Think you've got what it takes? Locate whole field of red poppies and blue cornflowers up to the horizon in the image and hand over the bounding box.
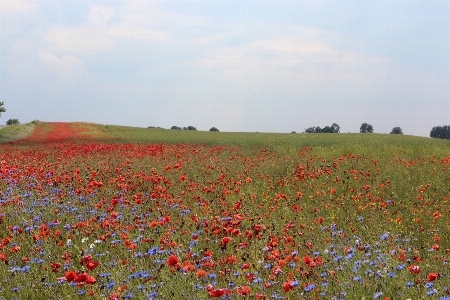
[0,122,450,299]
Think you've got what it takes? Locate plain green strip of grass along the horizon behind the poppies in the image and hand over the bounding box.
[78,123,450,151]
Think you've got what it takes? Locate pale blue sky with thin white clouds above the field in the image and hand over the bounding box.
[0,0,450,136]
